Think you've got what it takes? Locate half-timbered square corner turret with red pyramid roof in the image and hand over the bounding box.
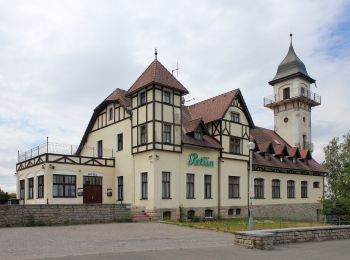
[127,54,188,153]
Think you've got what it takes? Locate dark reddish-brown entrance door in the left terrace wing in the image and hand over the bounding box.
[83,176,102,203]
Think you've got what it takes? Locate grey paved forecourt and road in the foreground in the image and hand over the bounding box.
[0,223,350,260]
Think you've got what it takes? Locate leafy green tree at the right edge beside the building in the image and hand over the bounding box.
[323,132,350,216]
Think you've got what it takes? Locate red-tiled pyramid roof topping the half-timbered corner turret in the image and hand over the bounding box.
[127,59,188,96]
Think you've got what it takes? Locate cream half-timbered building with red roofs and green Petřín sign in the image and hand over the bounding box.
[16,38,326,218]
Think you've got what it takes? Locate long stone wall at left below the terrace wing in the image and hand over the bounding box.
[0,204,130,227]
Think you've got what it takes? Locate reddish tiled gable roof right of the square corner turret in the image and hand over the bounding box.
[188,89,254,126]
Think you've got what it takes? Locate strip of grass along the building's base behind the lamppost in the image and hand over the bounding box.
[166,218,326,233]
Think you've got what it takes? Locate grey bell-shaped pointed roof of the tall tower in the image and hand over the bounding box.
[269,34,315,85]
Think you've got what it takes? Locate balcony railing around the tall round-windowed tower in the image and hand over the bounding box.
[264,88,321,106]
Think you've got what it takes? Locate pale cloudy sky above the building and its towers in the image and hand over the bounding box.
[0,0,350,192]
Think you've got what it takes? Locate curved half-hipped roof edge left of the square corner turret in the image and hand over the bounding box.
[77,88,131,155]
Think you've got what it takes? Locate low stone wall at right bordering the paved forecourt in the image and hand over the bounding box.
[234,225,350,249]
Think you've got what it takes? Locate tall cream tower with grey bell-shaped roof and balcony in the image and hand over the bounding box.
[264,34,321,151]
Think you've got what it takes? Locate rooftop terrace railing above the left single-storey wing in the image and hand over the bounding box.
[18,142,114,162]
